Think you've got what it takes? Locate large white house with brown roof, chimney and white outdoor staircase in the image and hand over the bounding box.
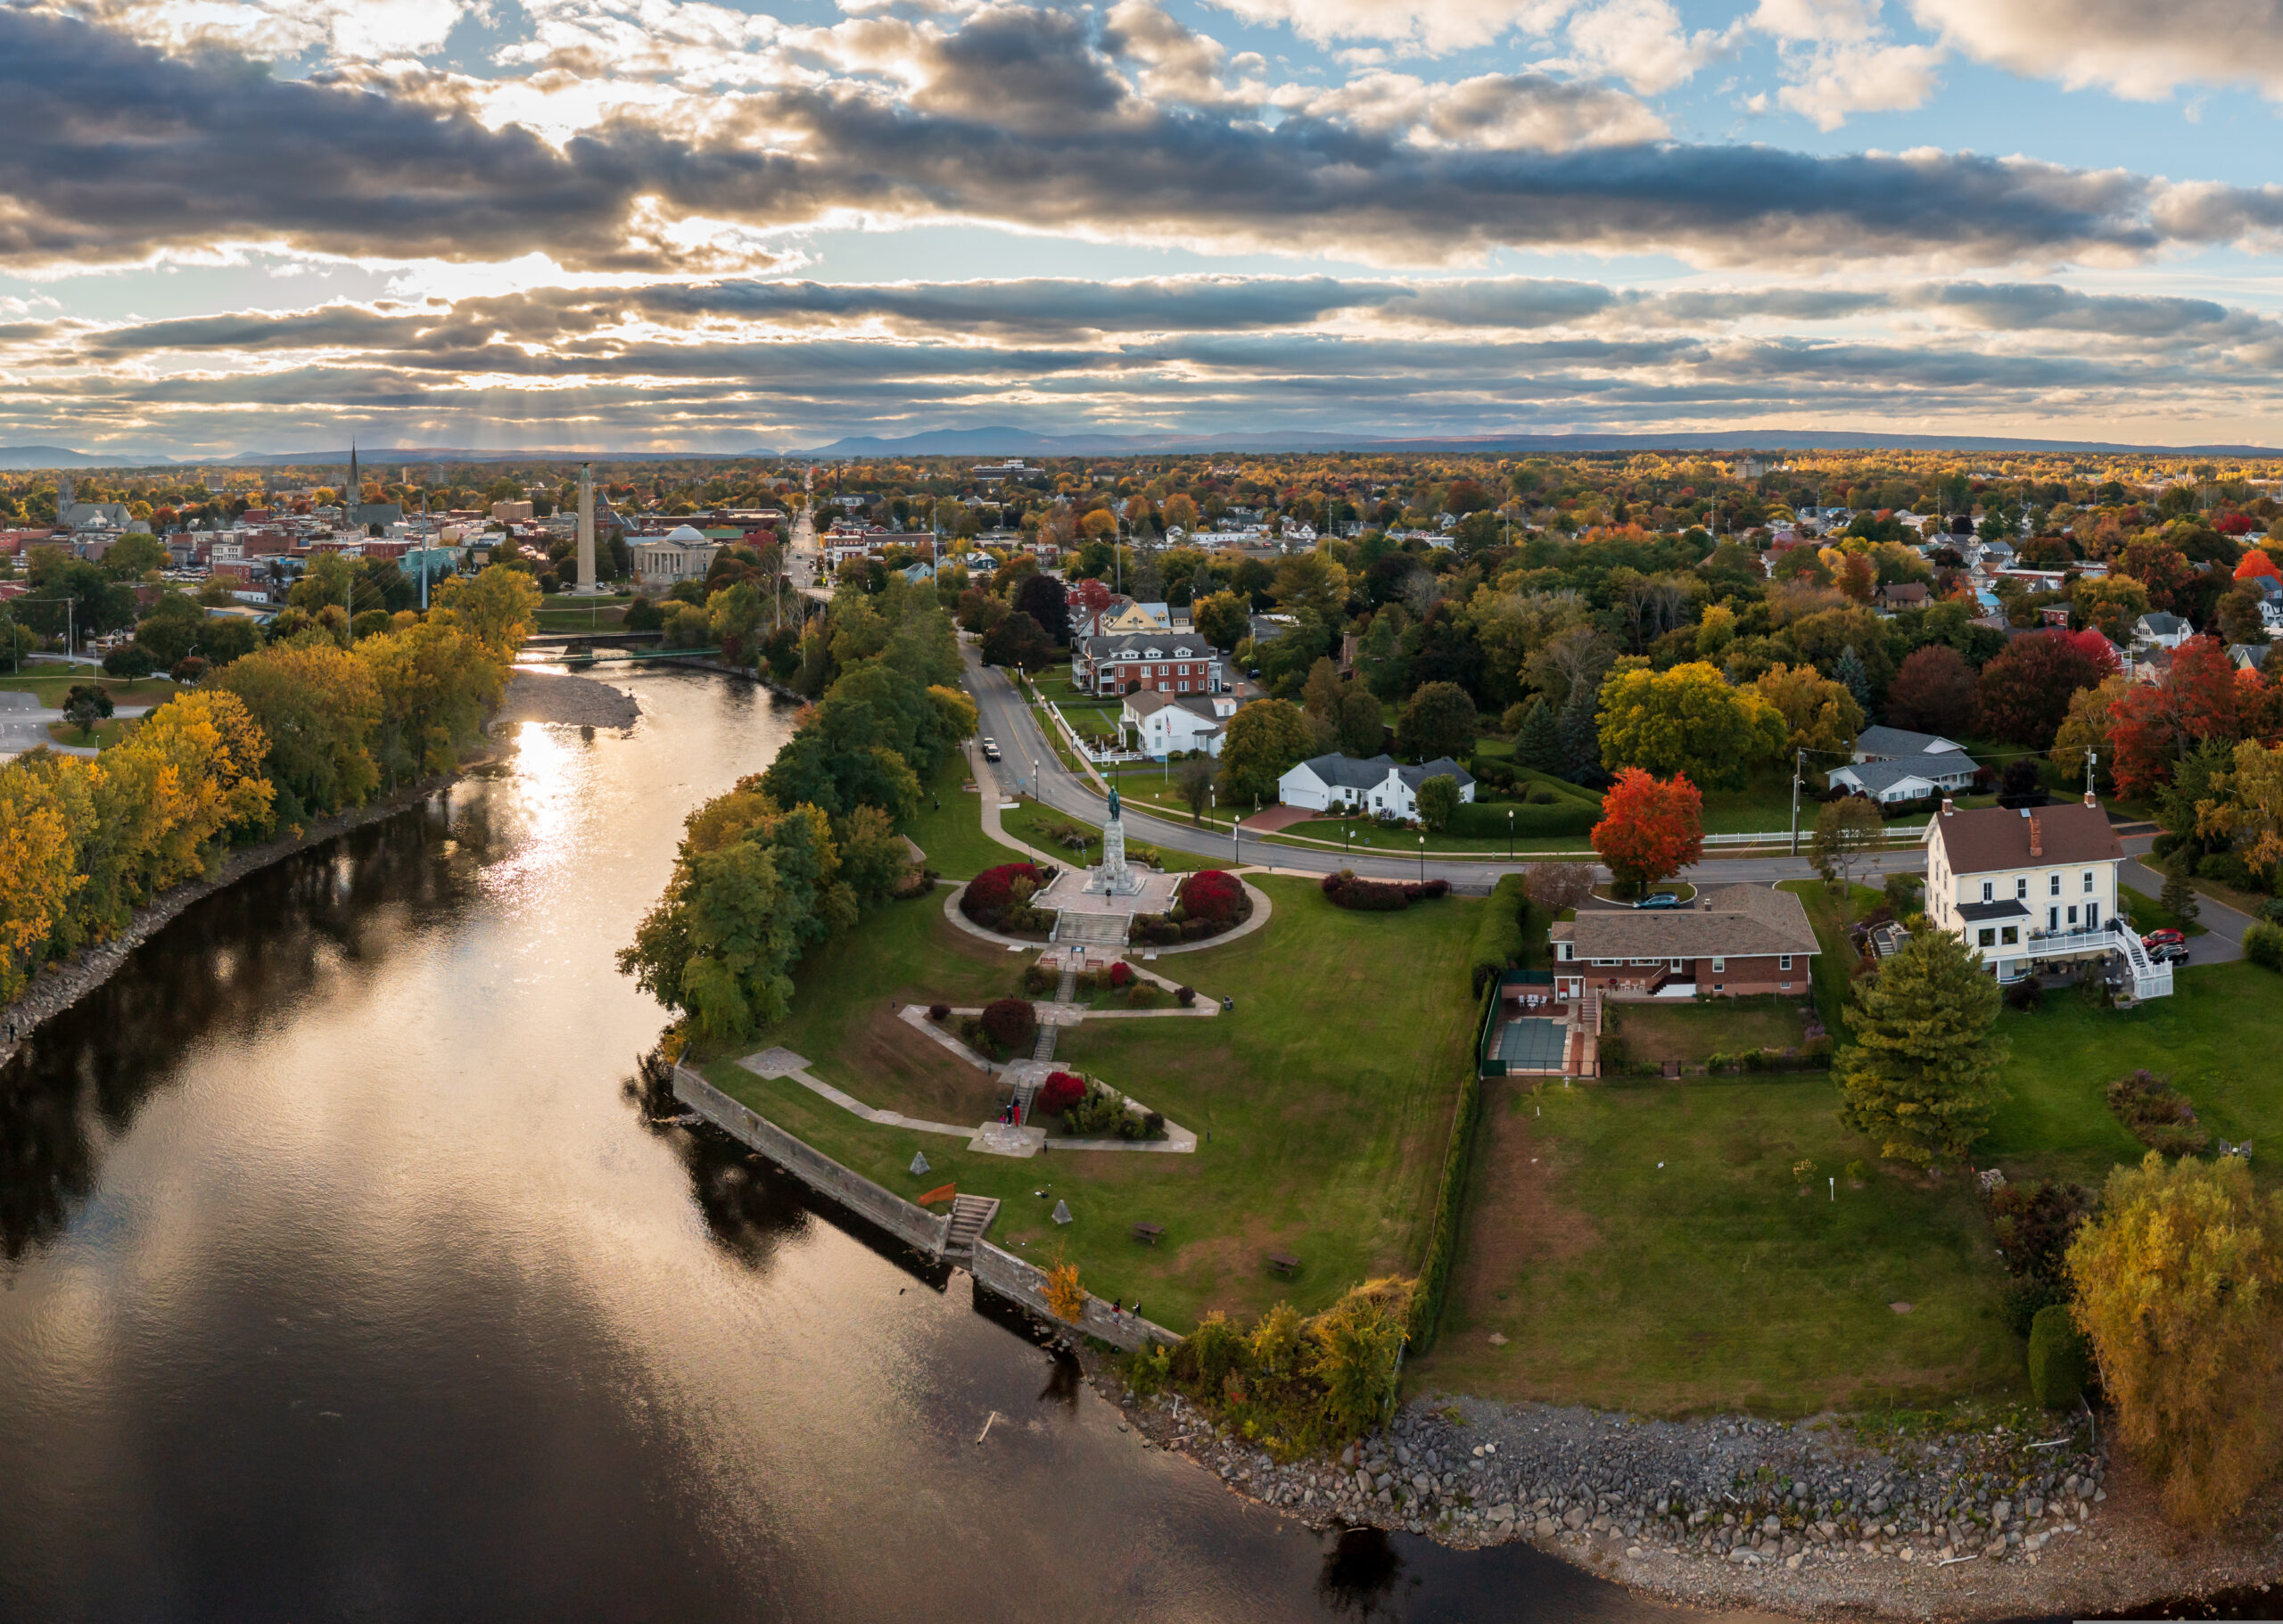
[1927,797,2172,998]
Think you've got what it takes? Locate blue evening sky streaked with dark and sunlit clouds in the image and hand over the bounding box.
[13,0,2283,459]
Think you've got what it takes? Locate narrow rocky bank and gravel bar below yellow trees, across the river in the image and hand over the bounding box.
[0,672,639,1065]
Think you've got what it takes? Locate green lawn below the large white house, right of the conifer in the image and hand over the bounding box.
[1977,961,2283,1188]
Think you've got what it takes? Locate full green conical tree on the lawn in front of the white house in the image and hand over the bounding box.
[1838,929,2007,1167]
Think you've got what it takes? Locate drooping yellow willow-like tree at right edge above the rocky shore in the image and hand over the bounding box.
[2068,1151,2283,1528]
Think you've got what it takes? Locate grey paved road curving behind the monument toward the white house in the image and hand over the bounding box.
[961,644,1927,884]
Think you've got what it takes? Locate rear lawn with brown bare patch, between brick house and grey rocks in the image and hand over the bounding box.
[1411,1074,2025,1416]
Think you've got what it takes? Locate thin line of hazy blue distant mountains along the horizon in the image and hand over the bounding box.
[0,425,2279,473]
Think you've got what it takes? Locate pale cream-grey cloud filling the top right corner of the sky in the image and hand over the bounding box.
[1911,0,2283,101]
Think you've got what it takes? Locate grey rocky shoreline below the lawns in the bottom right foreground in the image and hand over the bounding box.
[1096,1364,2283,1620]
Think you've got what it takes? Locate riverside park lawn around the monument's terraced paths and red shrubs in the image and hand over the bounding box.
[705,877,1481,1330]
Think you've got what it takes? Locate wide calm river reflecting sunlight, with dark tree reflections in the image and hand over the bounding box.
[0,674,1743,1621]
